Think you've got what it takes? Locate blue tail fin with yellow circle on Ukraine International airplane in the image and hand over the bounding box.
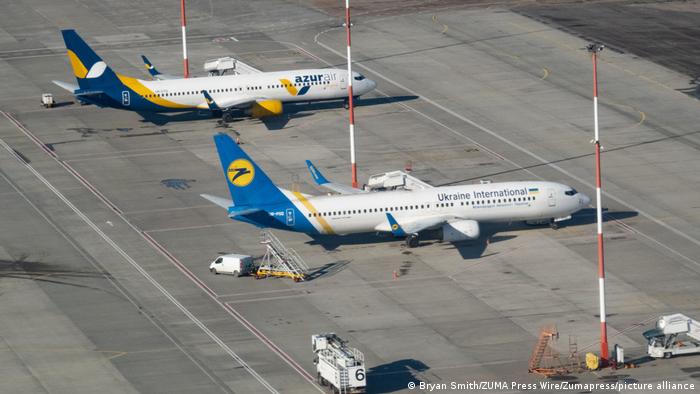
[214,133,289,207]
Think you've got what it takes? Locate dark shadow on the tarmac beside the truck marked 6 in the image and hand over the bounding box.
[367,358,430,393]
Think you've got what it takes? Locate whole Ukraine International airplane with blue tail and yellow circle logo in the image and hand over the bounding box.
[202,134,591,247]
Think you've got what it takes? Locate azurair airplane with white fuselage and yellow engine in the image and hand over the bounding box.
[53,30,377,118]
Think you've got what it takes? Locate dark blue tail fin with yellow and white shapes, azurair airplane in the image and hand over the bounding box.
[61,29,121,90]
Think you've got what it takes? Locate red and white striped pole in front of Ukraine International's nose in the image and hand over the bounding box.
[587,44,608,365]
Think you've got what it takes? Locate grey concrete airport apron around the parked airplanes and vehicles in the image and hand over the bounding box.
[0,1,700,393]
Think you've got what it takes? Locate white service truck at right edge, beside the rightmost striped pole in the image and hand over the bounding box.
[643,313,700,358]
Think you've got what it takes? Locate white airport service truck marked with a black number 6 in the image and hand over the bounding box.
[311,333,367,394]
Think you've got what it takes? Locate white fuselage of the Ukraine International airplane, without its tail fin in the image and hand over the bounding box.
[235,182,590,234]
